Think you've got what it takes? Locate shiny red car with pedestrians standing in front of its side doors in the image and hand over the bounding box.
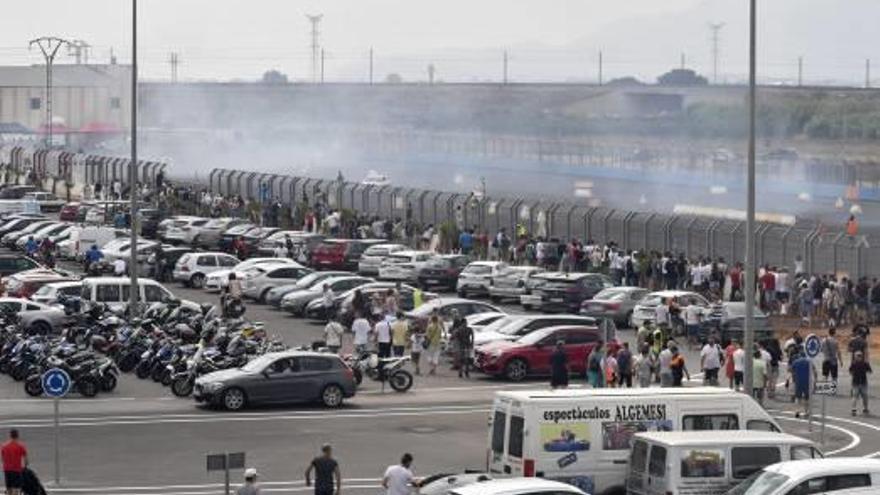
[476,326,619,382]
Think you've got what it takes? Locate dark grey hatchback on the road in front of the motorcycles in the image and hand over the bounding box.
[193,351,357,411]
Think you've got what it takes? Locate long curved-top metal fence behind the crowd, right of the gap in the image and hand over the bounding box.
[209,169,880,277]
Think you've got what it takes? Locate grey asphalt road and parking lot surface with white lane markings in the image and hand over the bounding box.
[0,260,880,495]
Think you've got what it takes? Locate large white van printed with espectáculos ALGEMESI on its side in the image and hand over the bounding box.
[487,387,782,495]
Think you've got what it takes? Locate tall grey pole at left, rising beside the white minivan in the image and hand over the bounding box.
[128,0,140,317]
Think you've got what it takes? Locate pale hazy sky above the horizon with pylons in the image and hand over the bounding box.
[0,0,880,84]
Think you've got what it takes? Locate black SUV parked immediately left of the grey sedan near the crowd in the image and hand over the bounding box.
[520,272,614,313]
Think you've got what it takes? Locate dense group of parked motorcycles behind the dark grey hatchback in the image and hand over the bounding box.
[0,301,285,397]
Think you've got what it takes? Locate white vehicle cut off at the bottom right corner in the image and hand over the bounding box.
[727,457,880,495]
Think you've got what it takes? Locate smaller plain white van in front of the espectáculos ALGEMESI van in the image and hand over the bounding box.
[626,431,823,495]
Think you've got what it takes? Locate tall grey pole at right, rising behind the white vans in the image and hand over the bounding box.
[743,0,758,395]
